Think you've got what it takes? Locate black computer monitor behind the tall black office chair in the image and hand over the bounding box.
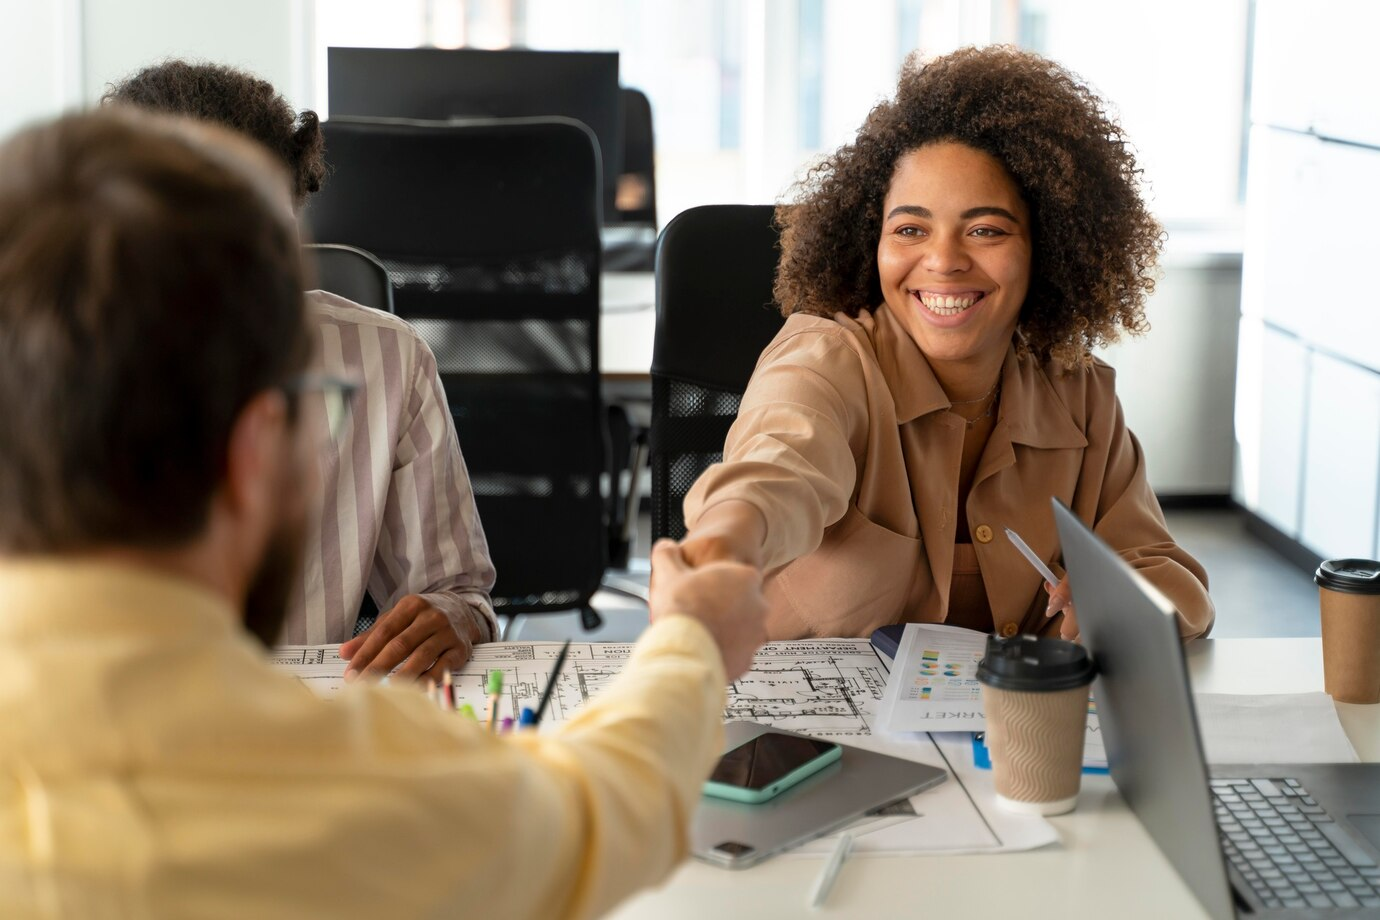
[326,48,622,221]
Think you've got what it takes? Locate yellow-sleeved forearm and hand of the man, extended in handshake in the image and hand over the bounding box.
[463,541,766,917]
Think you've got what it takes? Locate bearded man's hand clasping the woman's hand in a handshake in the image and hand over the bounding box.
[647,539,767,680]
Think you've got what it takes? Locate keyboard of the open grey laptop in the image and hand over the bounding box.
[1210,779,1380,908]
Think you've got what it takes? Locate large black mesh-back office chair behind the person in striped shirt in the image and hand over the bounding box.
[306,119,617,628]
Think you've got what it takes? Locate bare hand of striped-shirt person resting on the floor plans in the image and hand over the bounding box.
[341,594,484,680]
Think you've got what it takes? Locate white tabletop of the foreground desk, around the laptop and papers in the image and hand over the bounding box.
[611,639,1380,920]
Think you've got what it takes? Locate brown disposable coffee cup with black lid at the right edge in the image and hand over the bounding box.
[1314,559,1380,703]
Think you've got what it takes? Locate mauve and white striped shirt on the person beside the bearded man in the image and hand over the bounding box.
[280,291,498,644]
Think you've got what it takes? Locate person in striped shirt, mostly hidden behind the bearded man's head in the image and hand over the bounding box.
[102,61,498,679]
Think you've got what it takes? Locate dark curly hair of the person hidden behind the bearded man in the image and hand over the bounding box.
[101,61,326,208]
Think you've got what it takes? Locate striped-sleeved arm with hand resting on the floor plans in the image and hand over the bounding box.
[341,339,498,679]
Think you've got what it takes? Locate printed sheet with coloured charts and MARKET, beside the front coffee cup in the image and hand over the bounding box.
[878,623,987,731]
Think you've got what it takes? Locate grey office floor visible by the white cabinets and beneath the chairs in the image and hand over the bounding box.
[508,509,1318,641]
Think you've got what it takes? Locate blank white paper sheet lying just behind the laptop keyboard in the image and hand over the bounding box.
[1194,692,1361,764]
